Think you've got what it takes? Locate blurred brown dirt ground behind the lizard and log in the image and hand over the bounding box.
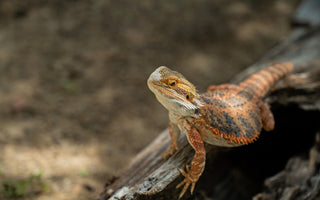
[0,0,298,200]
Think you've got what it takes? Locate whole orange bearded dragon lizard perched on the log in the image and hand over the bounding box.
[148,63,293,199]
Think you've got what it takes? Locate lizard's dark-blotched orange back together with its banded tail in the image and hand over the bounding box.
[194,63,293,146]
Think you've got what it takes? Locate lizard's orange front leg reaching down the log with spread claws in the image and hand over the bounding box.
[177,125,206,199]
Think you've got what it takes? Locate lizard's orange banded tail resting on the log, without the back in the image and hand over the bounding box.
[239,62,293,97]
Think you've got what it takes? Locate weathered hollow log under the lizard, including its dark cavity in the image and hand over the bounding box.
[101,0,320,200]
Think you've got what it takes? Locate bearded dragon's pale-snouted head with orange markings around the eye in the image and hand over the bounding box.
[148,66,202,117]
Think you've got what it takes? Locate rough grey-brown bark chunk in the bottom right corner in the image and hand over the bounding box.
[253,132,320,200]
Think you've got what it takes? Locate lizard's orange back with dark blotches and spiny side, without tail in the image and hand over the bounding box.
[197,89,262,146]
